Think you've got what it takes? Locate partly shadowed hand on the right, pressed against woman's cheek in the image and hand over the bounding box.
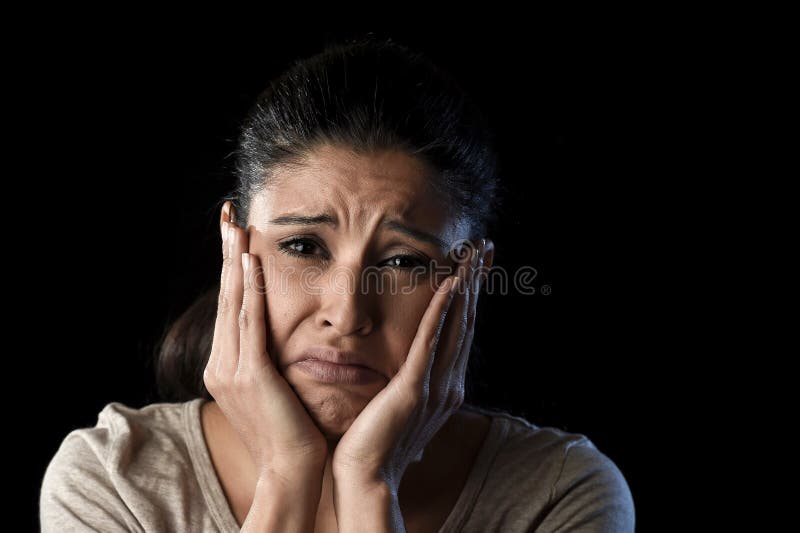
[332,241,483,495]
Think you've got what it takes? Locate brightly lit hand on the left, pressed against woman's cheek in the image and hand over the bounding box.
[203,206,327,482]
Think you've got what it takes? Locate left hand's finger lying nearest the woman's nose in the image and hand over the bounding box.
[239,253,274,373]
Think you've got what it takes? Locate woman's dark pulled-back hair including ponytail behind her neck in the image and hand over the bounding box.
[155,36,501,401]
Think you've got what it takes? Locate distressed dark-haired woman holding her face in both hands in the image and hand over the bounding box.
[40,35,634,531]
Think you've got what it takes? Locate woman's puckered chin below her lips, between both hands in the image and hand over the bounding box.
[292,383,380,440]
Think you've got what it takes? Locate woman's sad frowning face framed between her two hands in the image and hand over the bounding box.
[241,145,468,438]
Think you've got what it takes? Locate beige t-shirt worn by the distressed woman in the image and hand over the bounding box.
[39,398,634,533]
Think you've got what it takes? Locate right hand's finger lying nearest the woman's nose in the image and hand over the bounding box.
[398,276,459,388]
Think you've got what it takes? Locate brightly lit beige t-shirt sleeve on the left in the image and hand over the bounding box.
[39,428,144,533]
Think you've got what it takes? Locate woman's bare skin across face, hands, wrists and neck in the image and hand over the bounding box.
[203,146,493,531]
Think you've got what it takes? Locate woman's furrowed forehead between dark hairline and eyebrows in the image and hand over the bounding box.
[251,145,455,231]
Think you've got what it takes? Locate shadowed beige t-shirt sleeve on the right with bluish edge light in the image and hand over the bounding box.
[536,439,635,533]
